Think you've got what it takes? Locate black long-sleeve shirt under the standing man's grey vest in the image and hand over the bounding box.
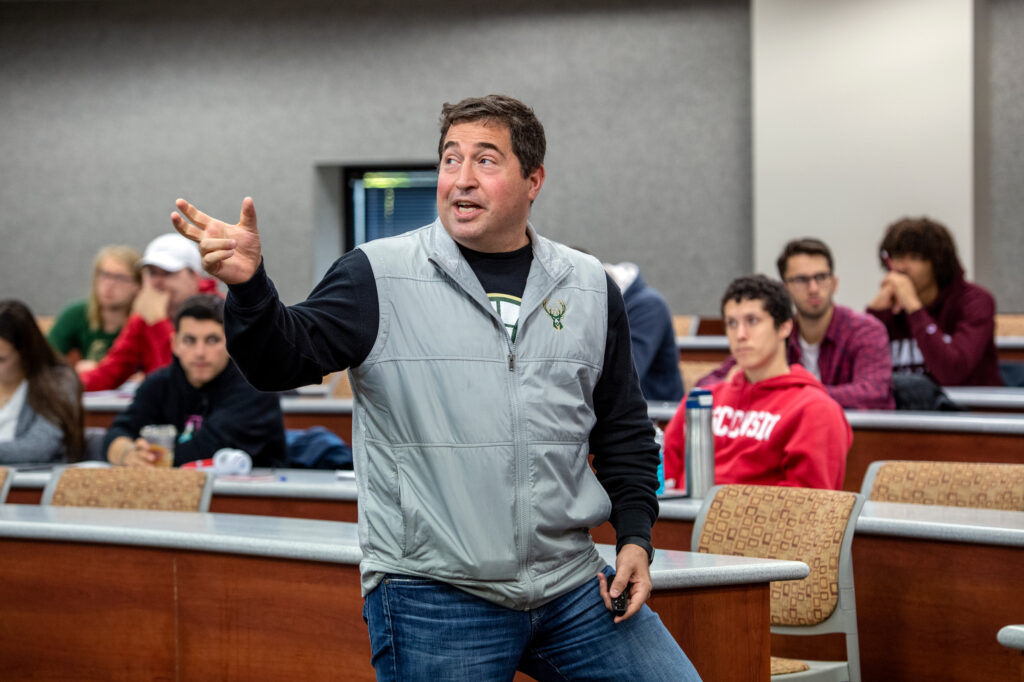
[224,246,658,551]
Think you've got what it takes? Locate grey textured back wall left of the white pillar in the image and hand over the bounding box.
[0,0,751,313]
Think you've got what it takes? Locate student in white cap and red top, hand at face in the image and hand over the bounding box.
[79,232,216,391]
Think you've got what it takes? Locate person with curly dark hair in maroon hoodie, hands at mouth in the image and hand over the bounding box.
[867,218,1002,386]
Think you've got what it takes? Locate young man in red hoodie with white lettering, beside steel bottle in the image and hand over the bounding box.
[665,274,853,489]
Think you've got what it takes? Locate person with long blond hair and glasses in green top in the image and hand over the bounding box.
[47,246,141,372]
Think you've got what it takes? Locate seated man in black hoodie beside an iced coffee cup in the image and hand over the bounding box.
[103,294,285,466]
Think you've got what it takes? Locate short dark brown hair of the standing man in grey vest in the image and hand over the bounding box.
[437,95,547,177]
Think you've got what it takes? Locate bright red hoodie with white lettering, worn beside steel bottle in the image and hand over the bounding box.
[665,365,853,491]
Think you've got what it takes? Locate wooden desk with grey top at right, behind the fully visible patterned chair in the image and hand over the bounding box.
[614,493,1024,682]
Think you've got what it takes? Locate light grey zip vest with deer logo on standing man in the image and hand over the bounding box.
[350,221,611,609]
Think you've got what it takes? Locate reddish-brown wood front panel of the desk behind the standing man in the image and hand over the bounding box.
[0,539,768,682]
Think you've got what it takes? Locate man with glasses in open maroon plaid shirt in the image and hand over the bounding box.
[697,238,895,410]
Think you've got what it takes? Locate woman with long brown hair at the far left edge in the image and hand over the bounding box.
[0,300,84,464]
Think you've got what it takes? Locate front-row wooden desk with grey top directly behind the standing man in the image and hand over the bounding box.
[0,505,808,681]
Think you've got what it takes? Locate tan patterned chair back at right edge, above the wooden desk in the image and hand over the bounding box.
[861,461,1024,511]
